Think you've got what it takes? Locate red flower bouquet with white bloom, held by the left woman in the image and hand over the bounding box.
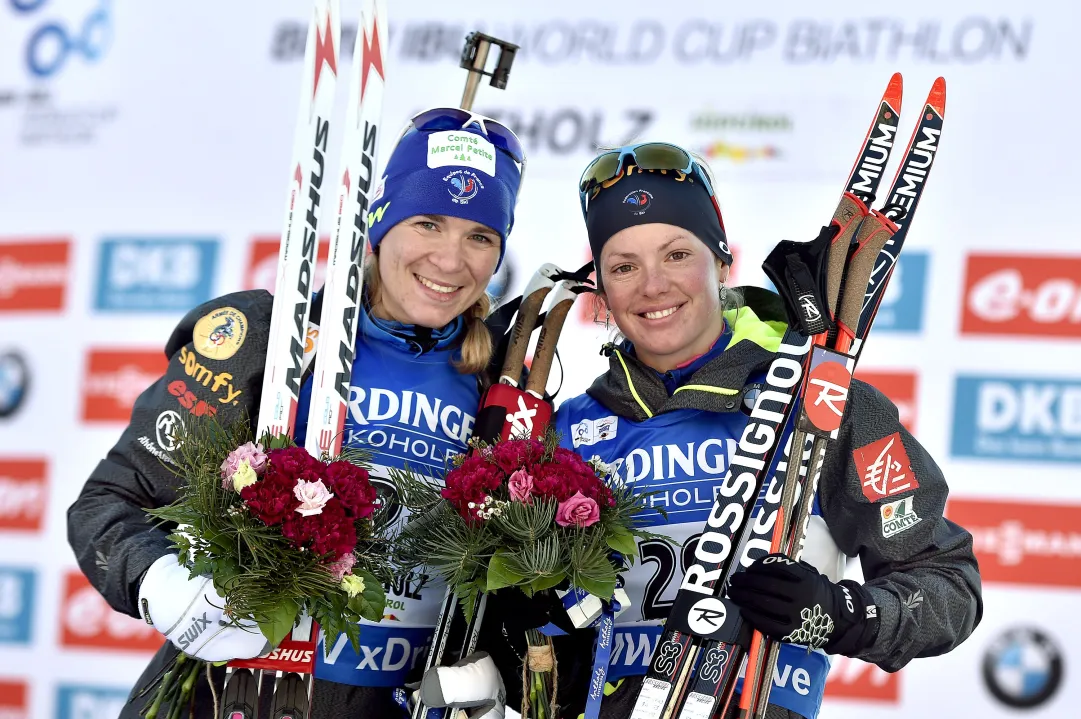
[146,417,390,717]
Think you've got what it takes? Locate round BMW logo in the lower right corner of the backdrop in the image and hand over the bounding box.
[984,627,1063,709]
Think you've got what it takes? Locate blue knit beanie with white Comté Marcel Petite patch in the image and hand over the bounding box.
[368,123,522,269]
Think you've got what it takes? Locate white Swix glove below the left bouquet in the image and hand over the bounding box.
[138,555,271,662]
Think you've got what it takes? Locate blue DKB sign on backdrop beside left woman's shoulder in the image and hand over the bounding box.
[94,238,217,312]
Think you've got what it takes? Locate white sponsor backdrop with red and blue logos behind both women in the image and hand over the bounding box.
[0,0,1081,719]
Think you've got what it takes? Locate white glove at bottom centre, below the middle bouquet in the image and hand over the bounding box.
[421,652,508,719]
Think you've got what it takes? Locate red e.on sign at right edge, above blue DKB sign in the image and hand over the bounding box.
[961,254,1081,337]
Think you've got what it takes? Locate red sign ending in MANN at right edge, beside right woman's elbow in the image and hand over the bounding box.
[946,500,1081,587]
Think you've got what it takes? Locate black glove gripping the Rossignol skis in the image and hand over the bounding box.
[729,554,878,656]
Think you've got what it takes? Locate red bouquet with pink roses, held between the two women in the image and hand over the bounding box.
[391,431,663,719]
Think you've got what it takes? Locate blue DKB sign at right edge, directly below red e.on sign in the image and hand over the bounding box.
[951,376,1081,462]
